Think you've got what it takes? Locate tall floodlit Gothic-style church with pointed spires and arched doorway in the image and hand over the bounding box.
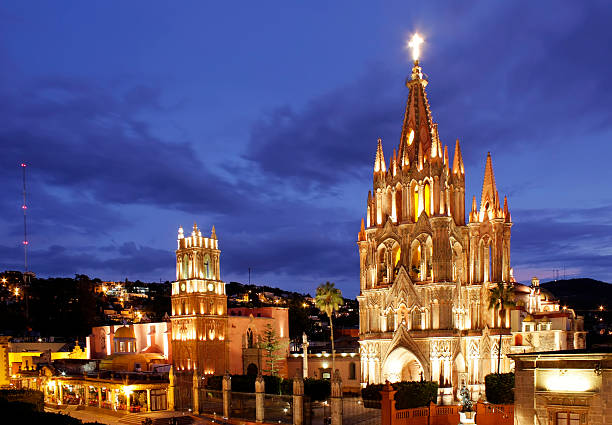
[357,57,512,391]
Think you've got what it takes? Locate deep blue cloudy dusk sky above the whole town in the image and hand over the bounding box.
[0,1,612,295]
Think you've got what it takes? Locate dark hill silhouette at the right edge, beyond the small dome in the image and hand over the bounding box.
[540,278,612,311]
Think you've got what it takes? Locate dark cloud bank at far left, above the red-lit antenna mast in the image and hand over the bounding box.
[0,78,250,212]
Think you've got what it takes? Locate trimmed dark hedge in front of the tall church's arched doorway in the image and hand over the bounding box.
[361,381,438,409]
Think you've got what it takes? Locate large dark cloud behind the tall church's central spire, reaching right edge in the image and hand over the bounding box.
[245,2,612,190]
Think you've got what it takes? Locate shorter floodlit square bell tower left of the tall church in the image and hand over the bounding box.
[170,223,229,375]
